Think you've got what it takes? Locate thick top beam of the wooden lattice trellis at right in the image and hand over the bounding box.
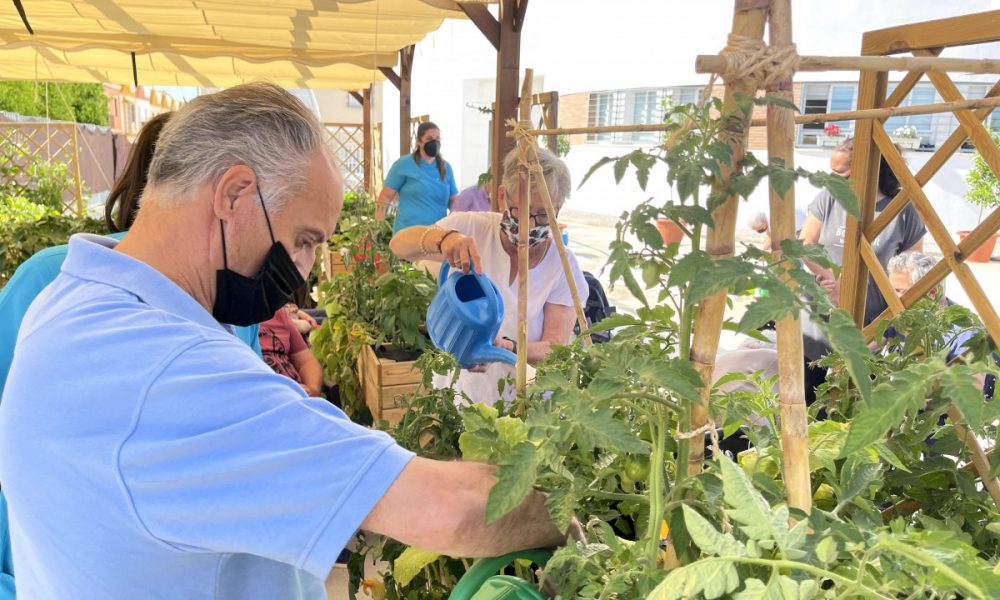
[861,10,1000,54]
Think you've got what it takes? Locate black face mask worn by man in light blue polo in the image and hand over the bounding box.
[212,185,305,327]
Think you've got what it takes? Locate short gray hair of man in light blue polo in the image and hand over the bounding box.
[149,83,324,211]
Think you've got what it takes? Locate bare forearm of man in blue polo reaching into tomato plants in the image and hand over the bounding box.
[361,457,566,558]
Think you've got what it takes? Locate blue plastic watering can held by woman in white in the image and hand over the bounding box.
[427,262,517,369]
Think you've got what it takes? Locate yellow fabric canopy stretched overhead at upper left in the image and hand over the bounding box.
[0,0,476,90]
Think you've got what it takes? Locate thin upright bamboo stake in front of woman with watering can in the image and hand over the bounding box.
[520,69,533,397]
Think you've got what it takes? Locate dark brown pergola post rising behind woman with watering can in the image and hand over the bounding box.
[490,0,527,210]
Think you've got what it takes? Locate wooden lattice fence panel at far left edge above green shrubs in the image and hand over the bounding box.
[0,121,84,215]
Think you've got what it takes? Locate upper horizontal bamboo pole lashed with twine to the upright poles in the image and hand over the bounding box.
[694,54,1000,75]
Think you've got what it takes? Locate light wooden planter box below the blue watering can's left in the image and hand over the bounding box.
[358,346,420,425]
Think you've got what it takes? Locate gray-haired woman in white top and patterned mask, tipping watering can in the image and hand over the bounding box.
[389,148,588,404]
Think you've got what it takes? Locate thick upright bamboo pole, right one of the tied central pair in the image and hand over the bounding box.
[767,0,812,513]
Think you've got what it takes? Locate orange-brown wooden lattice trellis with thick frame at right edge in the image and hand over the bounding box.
[841,18,1000,350]
